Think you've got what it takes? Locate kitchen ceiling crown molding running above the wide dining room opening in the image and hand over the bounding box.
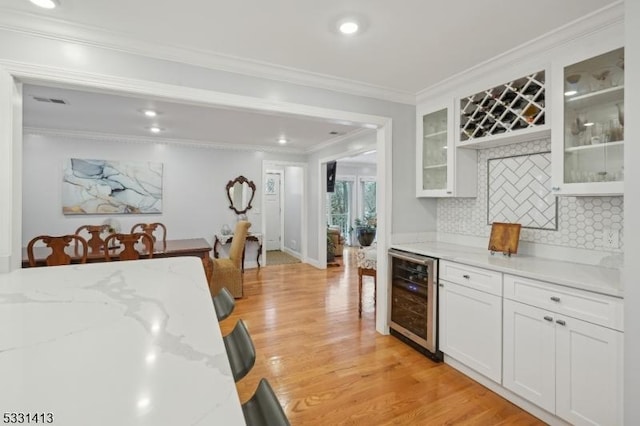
[0,9,415,105]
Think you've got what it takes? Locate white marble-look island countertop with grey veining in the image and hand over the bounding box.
[0,257,245,426]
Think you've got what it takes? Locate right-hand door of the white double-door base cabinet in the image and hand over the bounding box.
[555,317,623,425]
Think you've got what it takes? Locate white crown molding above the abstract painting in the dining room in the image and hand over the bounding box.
[23,126,306,155]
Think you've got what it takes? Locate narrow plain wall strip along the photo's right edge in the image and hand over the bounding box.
[623,0,640,425]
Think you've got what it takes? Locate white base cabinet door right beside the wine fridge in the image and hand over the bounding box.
[439,281,502,383]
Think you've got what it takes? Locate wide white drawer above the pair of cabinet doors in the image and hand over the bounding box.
[504,274,624,331]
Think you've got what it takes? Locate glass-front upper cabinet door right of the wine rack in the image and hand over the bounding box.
[552,48,624,195]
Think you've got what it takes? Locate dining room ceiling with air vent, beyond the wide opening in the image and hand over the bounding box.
[23,84,373,153]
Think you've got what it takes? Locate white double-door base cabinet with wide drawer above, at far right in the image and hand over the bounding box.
[503,275,623,425]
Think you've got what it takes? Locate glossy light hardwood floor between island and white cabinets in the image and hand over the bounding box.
[221,250,544,425]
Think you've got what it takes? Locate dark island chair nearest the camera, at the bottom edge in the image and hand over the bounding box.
[242,378,291,426]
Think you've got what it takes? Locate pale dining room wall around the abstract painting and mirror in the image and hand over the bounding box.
[22,134,300,250]
